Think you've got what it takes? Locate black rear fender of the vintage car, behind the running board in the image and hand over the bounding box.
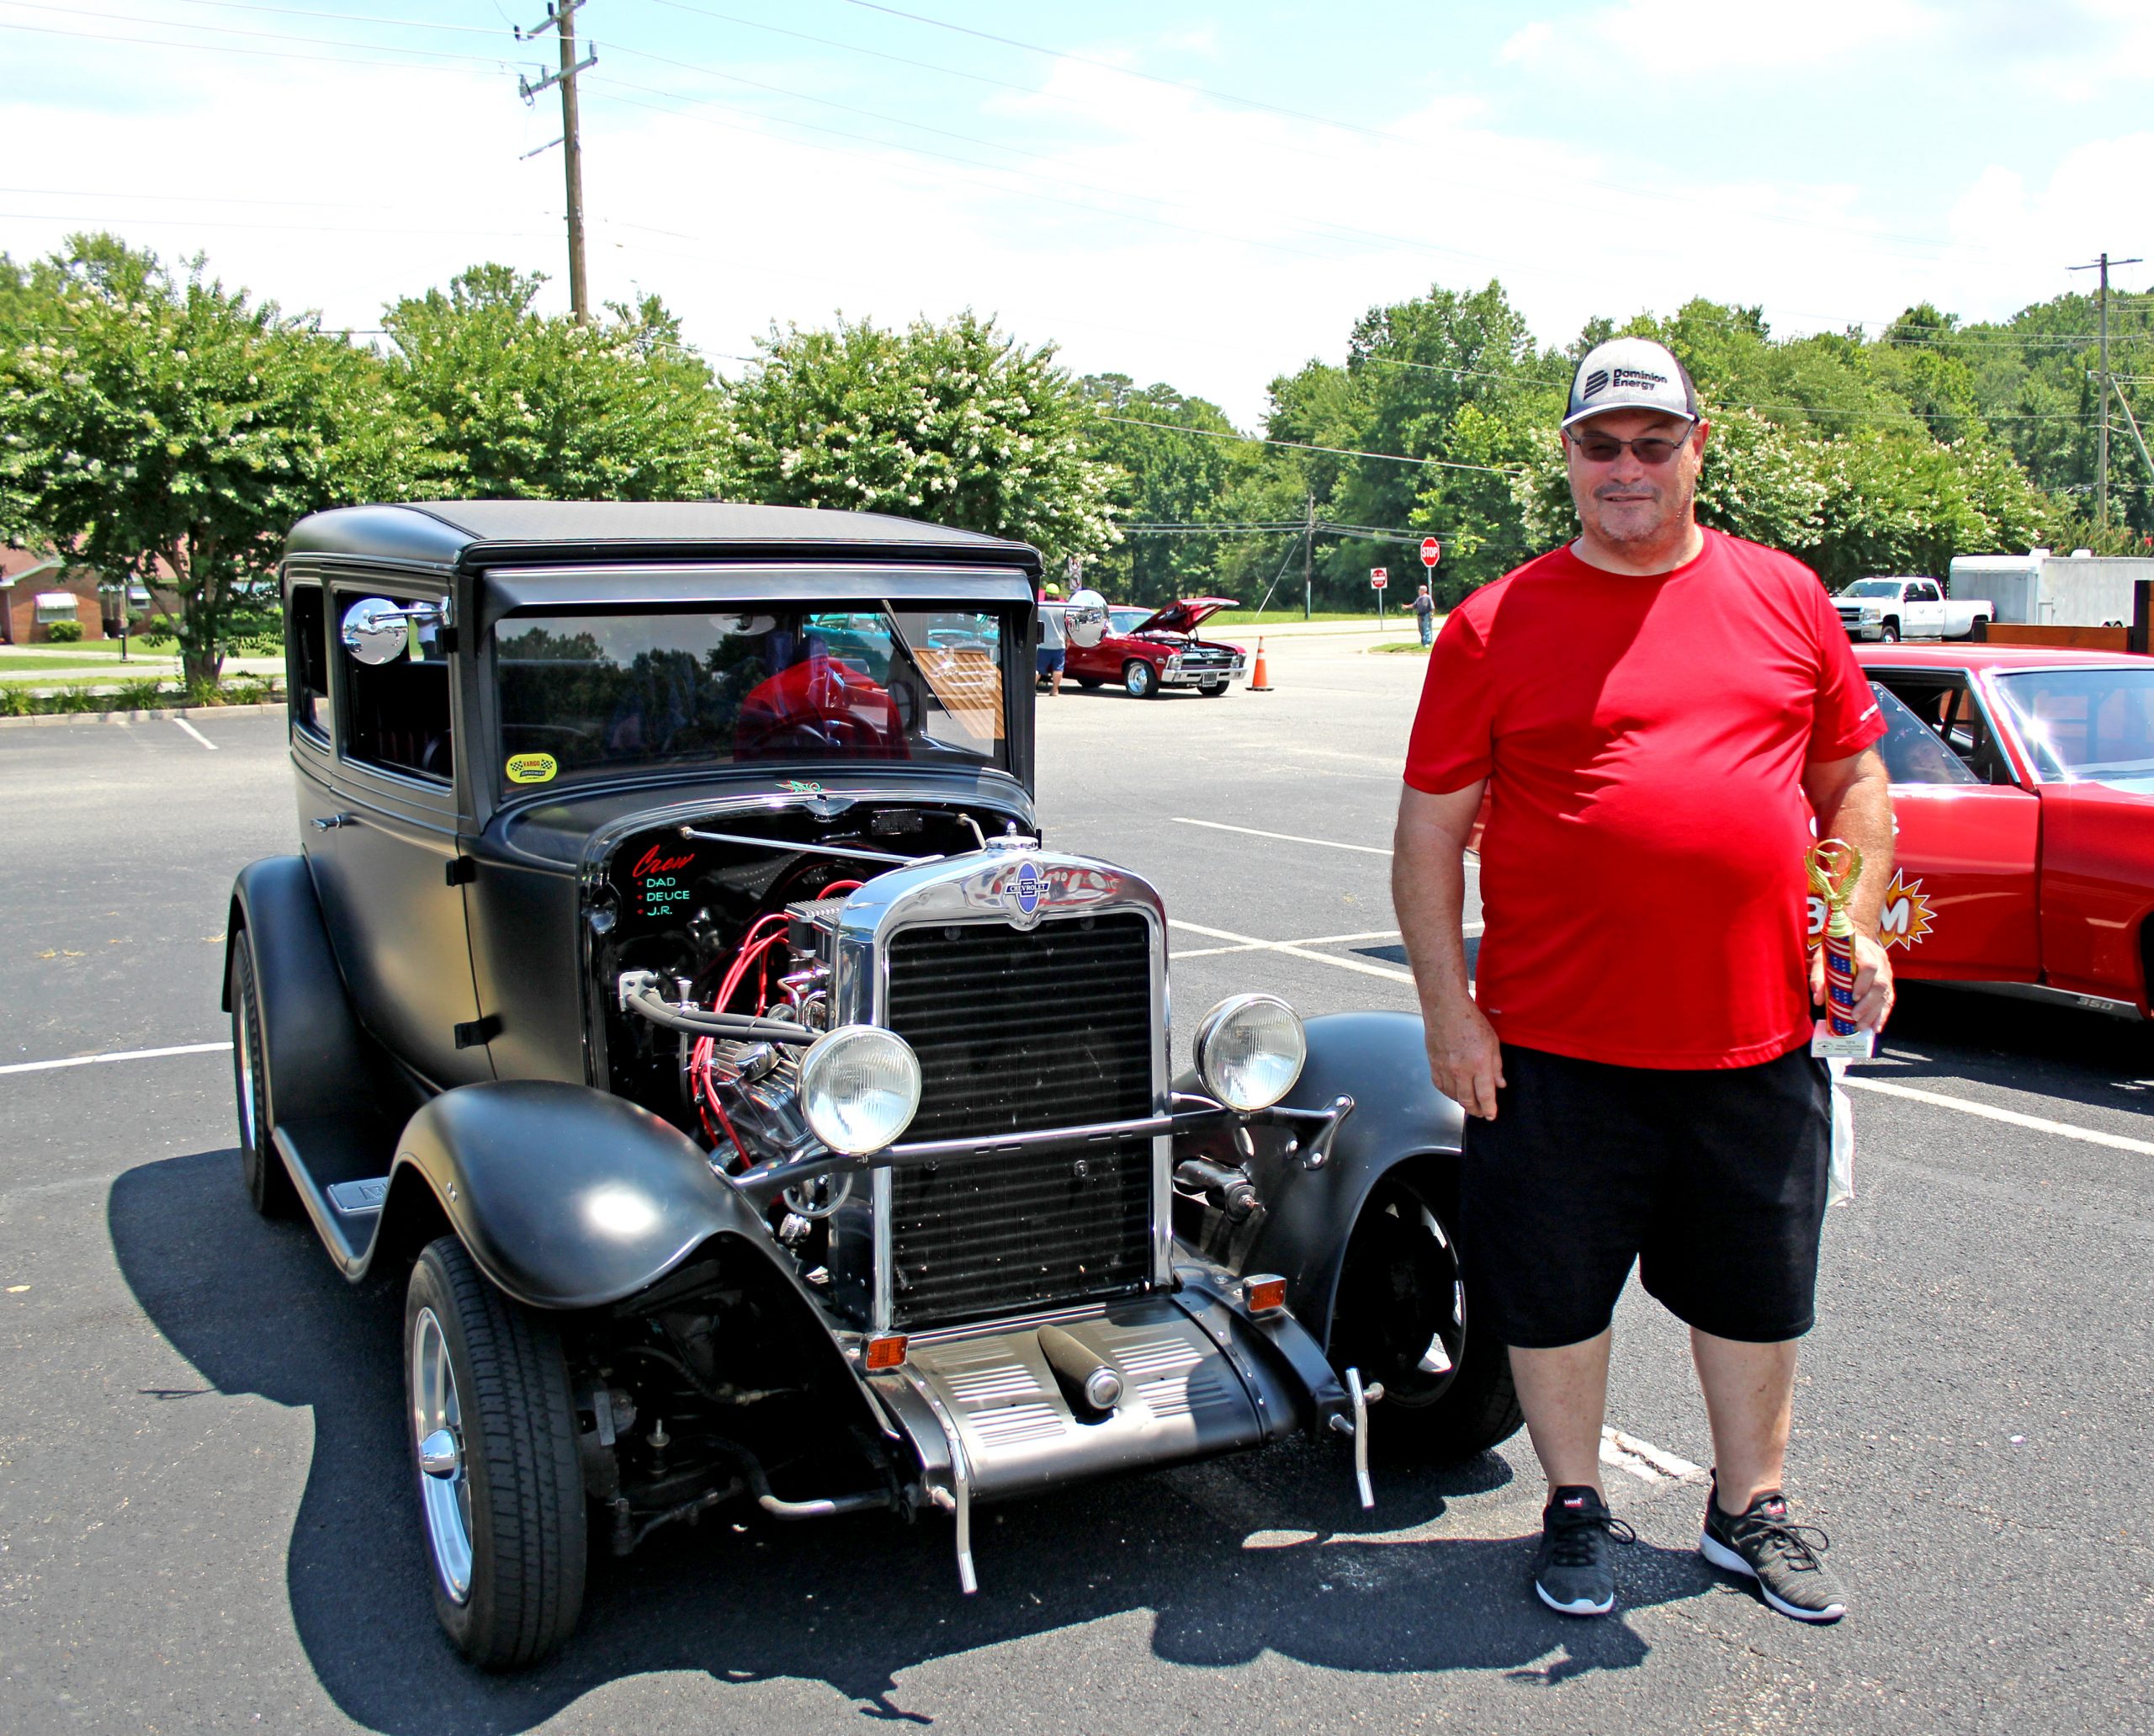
[220,855,377,1127]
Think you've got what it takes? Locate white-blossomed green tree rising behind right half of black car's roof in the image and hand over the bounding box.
[726,312,1116,562]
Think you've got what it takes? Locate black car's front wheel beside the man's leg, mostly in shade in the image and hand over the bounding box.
[1331,1167,1525,1464]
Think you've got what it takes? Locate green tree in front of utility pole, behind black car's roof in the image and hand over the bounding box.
[381,265,722,500]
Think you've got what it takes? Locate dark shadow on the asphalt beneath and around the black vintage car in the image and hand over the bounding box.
[108,1150,1711,1736]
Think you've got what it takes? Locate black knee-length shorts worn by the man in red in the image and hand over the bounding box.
[1458,1043,1833,1351]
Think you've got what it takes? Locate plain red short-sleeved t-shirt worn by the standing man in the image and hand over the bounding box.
[1407,530,1885,1069]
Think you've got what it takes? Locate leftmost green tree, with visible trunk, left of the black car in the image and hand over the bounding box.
[0,235,394,685]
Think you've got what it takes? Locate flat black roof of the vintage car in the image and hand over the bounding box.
[284,500,1040,573]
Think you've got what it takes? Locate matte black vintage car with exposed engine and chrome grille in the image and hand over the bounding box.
[226,502,1519,1667]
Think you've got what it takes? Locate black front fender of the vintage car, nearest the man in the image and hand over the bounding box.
[1176,1012,1465,1346]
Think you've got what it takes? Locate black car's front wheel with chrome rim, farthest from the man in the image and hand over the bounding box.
[405,1236,586,1670]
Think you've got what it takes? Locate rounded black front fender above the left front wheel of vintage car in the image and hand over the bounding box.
[381,1079,769,1309]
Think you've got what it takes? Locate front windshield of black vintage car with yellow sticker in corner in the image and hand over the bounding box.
[493,605,1015,786]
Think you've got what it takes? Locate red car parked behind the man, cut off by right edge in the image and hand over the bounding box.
[1852,644,2154,1017]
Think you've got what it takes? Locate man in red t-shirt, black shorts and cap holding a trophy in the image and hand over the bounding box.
[1392,338,1891,1622]
